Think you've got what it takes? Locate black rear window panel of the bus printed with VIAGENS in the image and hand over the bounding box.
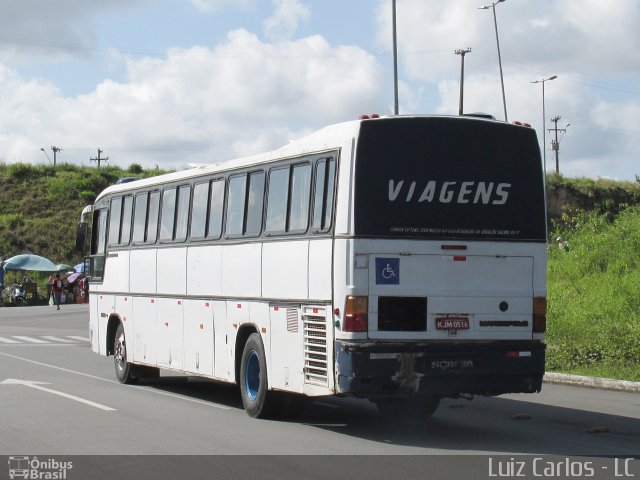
[354,117,546,242]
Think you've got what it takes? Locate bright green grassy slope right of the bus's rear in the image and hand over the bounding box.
[547,207,640,381]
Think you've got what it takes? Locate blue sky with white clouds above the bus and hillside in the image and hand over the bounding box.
[0,0,640,180]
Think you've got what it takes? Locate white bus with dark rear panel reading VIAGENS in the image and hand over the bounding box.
[80,116,546,417]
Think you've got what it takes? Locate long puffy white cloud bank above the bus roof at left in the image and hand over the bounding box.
[0,30,384,168]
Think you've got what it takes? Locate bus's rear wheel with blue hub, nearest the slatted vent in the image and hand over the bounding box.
[240,333,277,418]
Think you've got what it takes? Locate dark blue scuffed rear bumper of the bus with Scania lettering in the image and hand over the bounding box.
[335,341,546,398]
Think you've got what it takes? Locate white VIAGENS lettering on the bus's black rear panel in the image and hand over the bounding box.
[389,179,511,205]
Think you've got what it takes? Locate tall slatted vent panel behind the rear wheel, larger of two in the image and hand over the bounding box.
[302,309,329,387]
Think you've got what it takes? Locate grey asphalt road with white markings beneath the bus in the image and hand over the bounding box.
[0,305,640,478]
